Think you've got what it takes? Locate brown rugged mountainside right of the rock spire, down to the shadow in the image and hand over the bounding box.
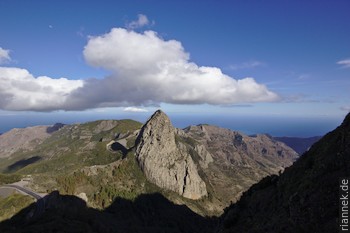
[184,125,298,205]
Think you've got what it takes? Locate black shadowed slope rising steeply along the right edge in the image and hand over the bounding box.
[219,114,350,233]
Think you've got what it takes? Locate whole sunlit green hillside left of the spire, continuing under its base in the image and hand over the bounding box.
[0,120,226,218]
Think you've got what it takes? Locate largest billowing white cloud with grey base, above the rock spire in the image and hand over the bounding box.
[72,28,279,108]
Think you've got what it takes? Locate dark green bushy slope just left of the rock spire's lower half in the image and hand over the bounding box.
[56,153,151,208]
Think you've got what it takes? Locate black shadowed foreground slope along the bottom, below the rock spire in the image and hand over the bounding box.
[0,192,216,233]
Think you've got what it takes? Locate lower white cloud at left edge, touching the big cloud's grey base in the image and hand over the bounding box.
[0,67,83,111]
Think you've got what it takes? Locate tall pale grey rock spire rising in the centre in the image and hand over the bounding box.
[136,110,207,199]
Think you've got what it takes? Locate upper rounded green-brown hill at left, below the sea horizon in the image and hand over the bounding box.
[0,120,142,174]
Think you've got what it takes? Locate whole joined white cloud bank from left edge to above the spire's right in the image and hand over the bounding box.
[0,28,279,111]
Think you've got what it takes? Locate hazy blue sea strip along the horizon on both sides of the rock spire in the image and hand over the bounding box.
[0,112,342,137]
